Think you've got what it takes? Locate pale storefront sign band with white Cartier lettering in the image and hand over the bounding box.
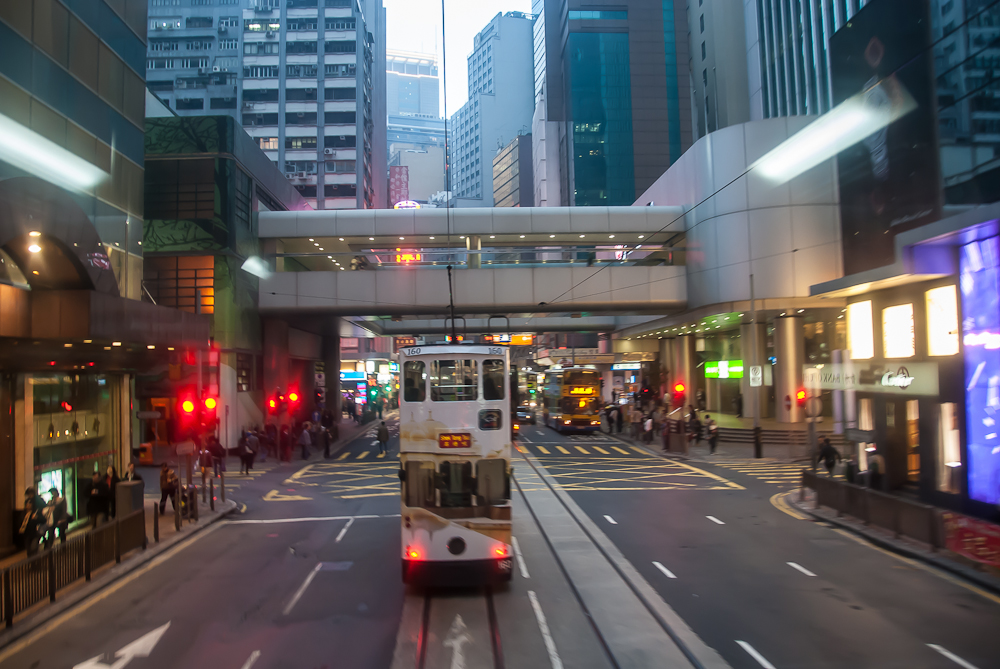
[804,362,938,396]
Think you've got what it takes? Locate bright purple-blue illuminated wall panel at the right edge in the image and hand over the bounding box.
[960,237,1000,504]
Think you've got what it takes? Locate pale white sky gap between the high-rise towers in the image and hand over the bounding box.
[383,0,531,117]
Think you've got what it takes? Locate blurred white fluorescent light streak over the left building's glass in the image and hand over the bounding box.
[0,114,111,190]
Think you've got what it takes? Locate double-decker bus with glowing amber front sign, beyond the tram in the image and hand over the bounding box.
[542,367,601,432]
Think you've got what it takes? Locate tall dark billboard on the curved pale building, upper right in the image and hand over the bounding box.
[829,0,942,274]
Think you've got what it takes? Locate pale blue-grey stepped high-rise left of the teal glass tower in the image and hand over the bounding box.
[448,12,534,207]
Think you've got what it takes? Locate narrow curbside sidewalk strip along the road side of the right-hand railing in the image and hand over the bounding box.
[785,488,1000,601]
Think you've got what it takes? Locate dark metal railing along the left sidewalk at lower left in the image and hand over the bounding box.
[0,509,146,627]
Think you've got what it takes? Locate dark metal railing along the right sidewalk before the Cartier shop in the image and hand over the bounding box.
[802,470,945,550]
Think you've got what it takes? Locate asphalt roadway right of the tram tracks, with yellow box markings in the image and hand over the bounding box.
[522,426,1000,669]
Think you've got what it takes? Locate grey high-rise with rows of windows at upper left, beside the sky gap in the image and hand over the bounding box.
[147,0,387,209]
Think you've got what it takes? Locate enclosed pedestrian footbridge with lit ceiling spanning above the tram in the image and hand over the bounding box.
[258,207,687,316]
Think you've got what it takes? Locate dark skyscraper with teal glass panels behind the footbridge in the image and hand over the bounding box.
[532,0,691,206]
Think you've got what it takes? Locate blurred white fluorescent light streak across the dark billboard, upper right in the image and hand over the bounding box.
[751,78,917,184]
